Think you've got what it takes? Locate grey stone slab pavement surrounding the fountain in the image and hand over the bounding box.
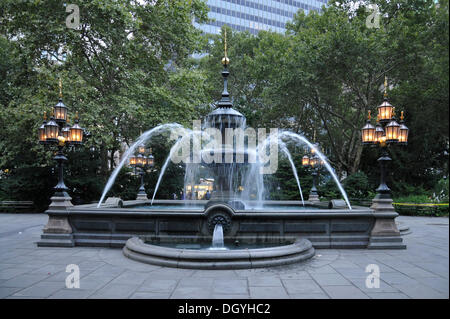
[0,214,449,299]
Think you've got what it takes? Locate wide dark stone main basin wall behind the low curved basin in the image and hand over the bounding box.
[38,200,406,249]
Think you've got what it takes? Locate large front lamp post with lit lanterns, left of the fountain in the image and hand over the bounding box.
[38,79,83,246]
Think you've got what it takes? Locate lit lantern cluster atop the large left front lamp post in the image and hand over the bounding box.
[38,80,83,146]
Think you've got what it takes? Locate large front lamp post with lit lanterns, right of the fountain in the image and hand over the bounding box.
[361,77,409,248]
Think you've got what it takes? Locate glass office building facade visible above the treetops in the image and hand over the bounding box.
[195,0,327,34]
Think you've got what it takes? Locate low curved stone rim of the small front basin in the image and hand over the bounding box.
[123,237,314,269]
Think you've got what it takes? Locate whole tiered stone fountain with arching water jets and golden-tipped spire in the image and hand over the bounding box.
[38,33,405,260]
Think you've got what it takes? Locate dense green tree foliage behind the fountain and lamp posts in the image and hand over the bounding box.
[0,0,449,210]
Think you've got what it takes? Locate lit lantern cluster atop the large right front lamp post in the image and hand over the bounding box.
[361,78,409,146]
